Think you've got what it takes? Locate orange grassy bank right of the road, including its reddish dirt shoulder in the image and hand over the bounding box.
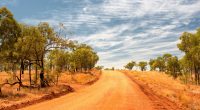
[122,70,200,110]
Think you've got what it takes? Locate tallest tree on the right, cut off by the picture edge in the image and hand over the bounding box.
[177,29,200,84]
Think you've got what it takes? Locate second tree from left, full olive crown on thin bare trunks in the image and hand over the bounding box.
[15,24,42,86]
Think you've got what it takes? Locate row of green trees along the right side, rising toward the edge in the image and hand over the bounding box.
[125,28,200,84]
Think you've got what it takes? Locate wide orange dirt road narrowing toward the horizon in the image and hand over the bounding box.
[20,71,153,110]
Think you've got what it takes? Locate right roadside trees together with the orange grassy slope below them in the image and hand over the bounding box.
[122,29,200,110]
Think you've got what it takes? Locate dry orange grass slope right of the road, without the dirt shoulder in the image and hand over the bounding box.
[124,71,200,110]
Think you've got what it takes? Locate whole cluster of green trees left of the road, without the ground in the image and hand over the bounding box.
[0,7,99,87]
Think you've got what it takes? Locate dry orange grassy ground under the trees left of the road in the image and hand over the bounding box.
[0,70,100,109]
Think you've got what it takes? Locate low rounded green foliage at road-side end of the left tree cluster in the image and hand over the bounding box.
[48,44,99,73]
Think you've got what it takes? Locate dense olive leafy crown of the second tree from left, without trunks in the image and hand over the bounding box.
[15,24,45,60]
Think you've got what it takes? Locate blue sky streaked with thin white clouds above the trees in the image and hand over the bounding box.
[0,0,200,68]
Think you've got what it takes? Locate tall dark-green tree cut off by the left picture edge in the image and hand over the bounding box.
[0,7,21,81]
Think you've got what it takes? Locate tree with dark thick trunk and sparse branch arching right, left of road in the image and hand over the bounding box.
[35,22,72,87]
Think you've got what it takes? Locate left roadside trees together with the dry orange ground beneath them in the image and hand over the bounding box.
[0,7,101,108]
